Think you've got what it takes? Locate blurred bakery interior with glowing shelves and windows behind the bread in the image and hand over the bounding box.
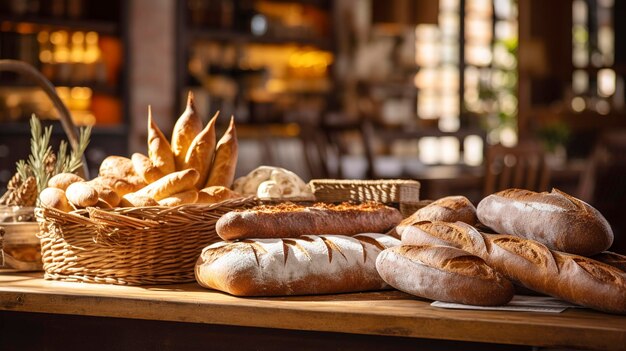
[0,0,626,245]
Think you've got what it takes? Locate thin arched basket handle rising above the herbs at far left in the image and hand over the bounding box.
[0,60,89,179]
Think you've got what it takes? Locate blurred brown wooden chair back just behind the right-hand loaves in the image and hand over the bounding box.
[483,141,550,196]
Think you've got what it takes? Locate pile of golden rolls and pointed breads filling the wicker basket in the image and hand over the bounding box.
[40,93,241,212]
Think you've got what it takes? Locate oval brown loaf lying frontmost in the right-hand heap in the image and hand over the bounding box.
[376,245,514,306]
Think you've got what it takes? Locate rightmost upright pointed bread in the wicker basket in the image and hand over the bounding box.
[204,117,238,188]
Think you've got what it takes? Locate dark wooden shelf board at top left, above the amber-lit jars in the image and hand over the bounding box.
[0,15,120,35]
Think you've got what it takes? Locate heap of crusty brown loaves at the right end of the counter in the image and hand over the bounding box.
[377,189,626,313]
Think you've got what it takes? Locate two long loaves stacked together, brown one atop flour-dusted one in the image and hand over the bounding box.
[195,203,402,296]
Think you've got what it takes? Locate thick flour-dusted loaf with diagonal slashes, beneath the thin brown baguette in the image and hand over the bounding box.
[195,234,399,296]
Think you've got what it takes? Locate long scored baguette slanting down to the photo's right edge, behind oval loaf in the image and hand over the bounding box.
[402,222,626,314]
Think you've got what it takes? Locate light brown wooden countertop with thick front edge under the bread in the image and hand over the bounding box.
[0,271,626,350]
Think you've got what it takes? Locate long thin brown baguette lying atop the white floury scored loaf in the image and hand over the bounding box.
[215,203,402,240]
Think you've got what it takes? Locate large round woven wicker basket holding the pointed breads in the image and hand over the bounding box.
[36,198,255,285]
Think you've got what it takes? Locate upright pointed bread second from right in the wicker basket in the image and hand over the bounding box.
[183,112,219,188]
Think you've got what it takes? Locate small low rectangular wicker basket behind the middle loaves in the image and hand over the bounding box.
[309,179,420,217]
